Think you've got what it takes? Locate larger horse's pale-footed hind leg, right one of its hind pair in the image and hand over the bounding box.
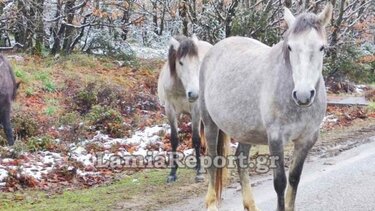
[236,143,258,211]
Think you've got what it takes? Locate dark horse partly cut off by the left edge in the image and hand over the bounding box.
[0,55,19,146]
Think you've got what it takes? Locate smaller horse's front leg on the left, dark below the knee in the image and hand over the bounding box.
[165,106,179,183]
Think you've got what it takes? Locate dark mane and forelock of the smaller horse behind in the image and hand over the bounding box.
[168,35,198,77]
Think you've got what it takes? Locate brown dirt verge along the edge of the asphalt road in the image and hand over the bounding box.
[113,118,375,210]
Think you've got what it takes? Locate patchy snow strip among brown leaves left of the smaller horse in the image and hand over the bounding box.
[0,124,176,187]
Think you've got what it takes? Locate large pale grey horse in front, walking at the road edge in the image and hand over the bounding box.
[198,3,332,210]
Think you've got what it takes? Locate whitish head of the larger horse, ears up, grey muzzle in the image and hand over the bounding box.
[283,4,332,106]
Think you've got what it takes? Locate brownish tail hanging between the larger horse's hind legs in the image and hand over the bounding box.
[215,130,230,201]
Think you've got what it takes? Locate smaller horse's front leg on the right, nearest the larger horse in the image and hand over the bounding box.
[191,106,204,182]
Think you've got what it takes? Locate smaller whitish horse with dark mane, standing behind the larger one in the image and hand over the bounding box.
[158,35,212,182]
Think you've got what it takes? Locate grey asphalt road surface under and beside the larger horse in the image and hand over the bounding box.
[163,137,375,211]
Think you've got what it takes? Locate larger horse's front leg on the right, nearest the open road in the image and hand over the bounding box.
[286,131,319,211]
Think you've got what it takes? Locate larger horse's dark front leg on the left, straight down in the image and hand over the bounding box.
[268,134,286,211]
